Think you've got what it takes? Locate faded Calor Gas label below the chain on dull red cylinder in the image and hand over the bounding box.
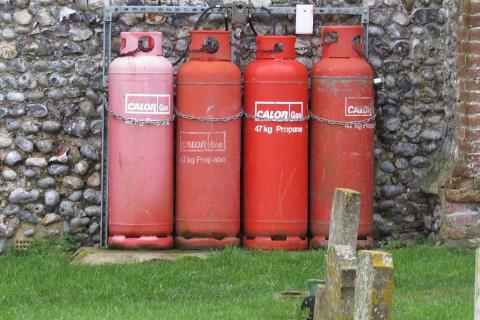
[179,131,227,152]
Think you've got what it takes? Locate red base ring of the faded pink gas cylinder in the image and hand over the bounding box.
[108,235,173,250]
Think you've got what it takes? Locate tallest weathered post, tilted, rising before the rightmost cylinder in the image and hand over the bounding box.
[328,188,361,249]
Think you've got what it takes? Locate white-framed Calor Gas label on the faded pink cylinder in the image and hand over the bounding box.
[125,93,170,114]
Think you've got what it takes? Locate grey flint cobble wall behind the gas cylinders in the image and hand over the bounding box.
[0,0,462,249]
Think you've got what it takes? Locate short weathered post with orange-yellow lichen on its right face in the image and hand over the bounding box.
[353,250,393,320]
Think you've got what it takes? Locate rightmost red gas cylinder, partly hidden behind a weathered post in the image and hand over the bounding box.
[309,26,375,248]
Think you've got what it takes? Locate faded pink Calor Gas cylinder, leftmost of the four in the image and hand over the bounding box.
[108,32,173,249]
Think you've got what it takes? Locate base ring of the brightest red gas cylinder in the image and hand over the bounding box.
[243,236,308,251]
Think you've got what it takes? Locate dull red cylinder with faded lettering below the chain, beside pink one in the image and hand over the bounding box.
[175,30,242,248]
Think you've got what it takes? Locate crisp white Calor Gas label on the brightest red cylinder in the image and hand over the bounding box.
[255,101,303,121]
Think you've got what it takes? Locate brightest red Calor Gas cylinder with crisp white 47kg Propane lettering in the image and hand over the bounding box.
[243,36,308,250]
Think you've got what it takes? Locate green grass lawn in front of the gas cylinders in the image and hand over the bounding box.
[0,244,475,320]
